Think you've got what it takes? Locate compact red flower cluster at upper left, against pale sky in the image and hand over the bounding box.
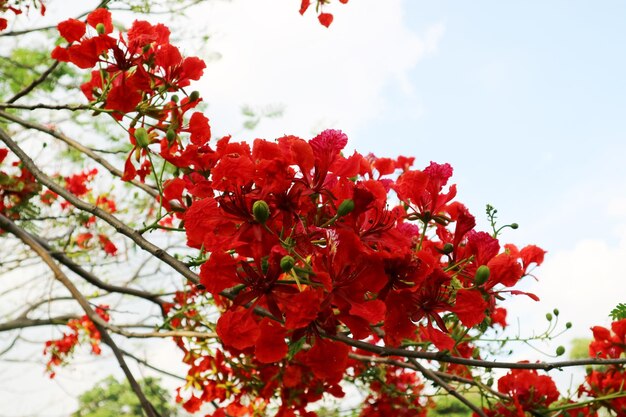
[52,9,205,119]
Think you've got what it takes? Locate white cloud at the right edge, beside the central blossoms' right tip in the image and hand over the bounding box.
[504,187,626,345]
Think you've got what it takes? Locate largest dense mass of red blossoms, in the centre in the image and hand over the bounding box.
[155,130,544,415]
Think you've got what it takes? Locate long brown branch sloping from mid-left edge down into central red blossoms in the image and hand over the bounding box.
[0,125,200,284]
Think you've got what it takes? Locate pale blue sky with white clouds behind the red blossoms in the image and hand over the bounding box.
[0,0,626,417]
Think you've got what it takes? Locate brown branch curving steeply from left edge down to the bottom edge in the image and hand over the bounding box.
[0,214,160,417]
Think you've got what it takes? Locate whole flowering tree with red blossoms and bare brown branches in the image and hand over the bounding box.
[0,0,626,417]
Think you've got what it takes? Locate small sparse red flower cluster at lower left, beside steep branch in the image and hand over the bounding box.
[43,305,110,378]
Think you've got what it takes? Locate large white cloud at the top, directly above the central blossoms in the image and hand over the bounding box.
[193,0,445,139]
